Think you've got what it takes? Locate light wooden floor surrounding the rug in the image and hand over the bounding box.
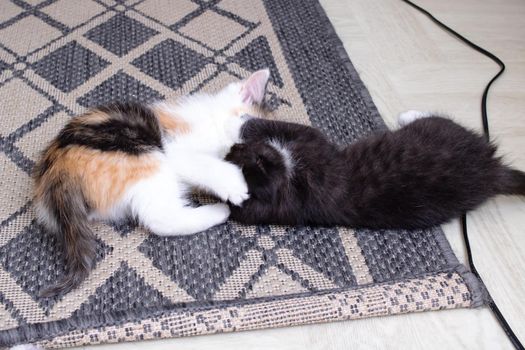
[70,0,525,350]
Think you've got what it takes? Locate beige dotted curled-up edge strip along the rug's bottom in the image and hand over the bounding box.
[37,272,473,349]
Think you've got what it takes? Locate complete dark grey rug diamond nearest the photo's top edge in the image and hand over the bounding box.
[84,13,158,56]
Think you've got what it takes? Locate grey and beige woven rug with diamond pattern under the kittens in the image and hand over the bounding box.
[0,0,482,348]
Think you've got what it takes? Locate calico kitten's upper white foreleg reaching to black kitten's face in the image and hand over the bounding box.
[175,154,250,206]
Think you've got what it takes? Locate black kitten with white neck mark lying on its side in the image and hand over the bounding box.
[226,112,525,229]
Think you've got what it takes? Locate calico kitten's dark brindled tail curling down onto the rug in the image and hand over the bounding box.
[39,179,97,297]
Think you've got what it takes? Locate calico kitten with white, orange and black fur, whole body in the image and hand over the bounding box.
[34,70,269,296]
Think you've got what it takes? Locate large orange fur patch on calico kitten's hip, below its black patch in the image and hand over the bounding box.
[36,145,160,214]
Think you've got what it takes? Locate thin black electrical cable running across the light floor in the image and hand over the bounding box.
[401,0,525,350]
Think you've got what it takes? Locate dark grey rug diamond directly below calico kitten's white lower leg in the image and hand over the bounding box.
[139,224,255,300]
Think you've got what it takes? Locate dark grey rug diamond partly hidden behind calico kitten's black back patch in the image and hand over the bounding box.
[78,71,162,107]
